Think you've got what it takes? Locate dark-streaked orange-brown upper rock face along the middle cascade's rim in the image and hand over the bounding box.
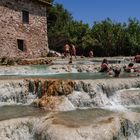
[28,79,75,98]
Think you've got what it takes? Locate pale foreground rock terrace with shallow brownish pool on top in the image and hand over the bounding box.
[0,109,136,140]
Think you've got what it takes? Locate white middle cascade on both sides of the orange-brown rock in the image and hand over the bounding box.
[0,79,140,107]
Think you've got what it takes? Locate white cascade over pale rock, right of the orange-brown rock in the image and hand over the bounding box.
[68,79,140,110]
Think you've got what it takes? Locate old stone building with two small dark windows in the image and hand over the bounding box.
[0,0,49,58]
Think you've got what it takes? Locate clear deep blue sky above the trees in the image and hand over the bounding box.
[55,0,140,26]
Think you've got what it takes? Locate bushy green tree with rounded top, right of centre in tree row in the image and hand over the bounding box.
[92,18,126,56]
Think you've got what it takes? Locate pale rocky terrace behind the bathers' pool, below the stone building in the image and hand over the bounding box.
[0,57,140,75]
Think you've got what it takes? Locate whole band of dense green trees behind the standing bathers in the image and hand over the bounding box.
[48,4,140,56]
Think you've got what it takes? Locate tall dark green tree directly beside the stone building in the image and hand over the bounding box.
[48,4,72,51]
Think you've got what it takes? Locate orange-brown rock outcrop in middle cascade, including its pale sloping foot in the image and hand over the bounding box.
[34,80,74,111]
